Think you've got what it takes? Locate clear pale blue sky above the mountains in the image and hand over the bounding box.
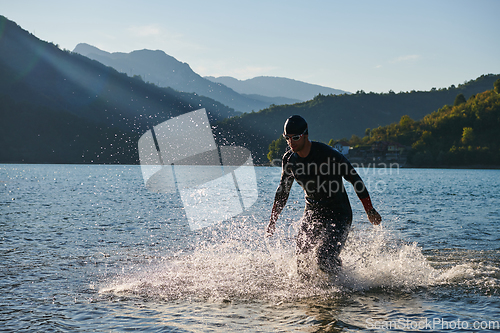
[0,0,500,92]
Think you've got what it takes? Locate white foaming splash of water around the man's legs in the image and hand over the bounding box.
[100,221,461,302]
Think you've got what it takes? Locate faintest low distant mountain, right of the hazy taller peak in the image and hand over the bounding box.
[205,76,348,104]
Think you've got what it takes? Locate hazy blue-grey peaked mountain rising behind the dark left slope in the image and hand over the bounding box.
[73,43,298,112]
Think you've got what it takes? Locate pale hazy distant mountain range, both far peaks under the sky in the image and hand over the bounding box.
[73,43,344,112]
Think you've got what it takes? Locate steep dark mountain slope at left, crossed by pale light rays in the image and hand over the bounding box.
[0,16,236,163]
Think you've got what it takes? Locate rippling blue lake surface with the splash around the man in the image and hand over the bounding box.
[0,165,500,332]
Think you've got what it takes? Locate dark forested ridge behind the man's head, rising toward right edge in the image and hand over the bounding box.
[213,74,500,164]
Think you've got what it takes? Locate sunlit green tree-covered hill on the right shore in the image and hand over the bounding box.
[330,79,500,166]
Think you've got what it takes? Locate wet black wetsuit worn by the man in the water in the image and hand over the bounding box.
[275,141,369,273]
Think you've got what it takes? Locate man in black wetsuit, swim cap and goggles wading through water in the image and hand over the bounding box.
[267,115,382,278]
